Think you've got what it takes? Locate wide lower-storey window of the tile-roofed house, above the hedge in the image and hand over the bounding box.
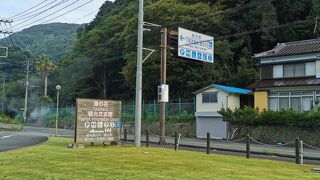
[269,91,314,111]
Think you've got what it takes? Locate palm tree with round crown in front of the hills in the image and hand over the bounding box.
[35,55,56,97]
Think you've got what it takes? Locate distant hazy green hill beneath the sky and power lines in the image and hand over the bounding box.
[9,23,81,61]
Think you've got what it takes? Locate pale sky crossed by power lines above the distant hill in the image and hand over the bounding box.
[0,0,106,32]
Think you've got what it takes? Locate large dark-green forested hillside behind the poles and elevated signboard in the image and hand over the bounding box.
[56,0,320,101]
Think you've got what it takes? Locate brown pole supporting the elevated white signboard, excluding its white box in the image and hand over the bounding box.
[159,28,168,145]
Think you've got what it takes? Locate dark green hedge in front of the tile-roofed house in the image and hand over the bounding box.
[219,107,320,128]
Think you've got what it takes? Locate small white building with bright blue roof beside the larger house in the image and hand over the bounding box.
[195,84,252,139]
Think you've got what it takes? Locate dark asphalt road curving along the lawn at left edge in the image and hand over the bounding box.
[0,131,48,152]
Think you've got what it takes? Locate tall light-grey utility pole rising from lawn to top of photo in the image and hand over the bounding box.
[134,0,143,147]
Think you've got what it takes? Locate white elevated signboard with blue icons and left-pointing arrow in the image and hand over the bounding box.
[178,28,214,63]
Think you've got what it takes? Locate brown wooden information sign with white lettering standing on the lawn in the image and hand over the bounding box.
[75,99,121,144]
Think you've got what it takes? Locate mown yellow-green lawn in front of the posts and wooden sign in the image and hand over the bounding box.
[0,138,320,180]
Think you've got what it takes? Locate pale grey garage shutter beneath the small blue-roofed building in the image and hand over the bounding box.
[197,117,227,139]
